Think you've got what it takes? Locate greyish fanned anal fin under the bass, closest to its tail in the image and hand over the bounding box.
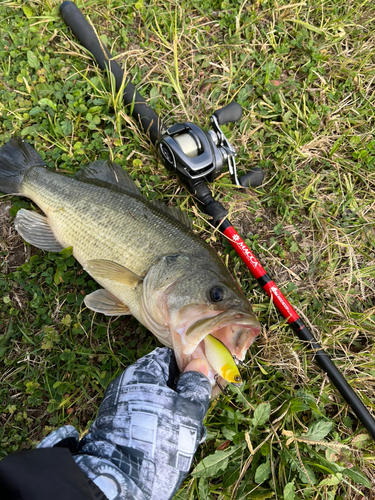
[14,208,63,252]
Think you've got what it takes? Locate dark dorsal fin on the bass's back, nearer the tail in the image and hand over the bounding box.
[75,160,141,196]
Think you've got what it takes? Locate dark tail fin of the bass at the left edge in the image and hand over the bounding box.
[0,137,45,194]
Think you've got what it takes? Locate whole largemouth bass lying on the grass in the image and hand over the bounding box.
[0,137,260,396]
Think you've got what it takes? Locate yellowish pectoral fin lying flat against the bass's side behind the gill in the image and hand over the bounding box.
[83,259,143,287]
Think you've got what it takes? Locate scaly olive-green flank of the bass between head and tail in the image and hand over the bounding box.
[21,167,216,274]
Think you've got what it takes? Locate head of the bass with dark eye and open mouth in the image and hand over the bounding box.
[142,254,260,392]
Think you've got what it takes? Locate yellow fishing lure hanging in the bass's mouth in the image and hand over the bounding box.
[204,335,242,384]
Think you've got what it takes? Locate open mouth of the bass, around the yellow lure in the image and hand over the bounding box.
[175,311,260,396]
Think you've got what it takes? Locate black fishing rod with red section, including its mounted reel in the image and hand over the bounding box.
[60,1,375,440]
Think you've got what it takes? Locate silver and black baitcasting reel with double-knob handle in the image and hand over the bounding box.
[156,102,264,187]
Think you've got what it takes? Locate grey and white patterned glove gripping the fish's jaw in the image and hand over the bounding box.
[39,347,211,500]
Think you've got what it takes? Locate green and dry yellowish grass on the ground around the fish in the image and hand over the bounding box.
[0,0,375,500]
